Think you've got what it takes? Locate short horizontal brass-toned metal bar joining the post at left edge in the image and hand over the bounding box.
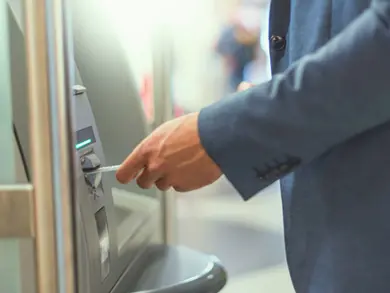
[0,184,34,238]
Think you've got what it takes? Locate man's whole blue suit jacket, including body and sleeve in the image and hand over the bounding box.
[199,0,390,293]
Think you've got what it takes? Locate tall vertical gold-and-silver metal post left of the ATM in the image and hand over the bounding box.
[24,0,76,293]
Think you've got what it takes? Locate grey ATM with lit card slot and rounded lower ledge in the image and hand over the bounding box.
[8,0,227,293]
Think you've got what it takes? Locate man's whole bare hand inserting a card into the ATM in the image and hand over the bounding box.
[116,113,222,192]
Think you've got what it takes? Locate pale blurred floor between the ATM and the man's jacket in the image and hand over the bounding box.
[178,179,294,293]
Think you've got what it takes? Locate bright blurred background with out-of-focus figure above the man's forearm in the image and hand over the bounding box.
[105,0,269,116]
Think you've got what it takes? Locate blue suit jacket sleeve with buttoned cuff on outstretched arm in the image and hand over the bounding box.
[199,0,390,199]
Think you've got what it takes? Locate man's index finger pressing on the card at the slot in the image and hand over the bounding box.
[116,146,147,184]
